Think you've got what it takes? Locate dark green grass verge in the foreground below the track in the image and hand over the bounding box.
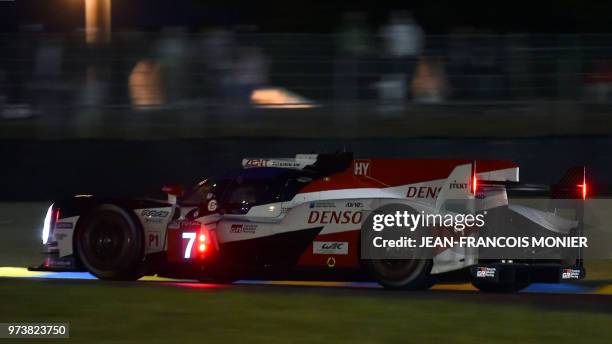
[0,280,612,344]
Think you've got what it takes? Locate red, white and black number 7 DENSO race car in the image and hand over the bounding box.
[30,153,586,291]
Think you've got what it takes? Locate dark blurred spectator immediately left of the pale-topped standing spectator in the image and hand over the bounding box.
[334,12,369,105]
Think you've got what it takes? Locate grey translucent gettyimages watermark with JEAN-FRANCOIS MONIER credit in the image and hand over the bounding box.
[361,200,612,259]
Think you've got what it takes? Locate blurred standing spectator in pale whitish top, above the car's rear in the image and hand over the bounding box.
[379,11,424,111]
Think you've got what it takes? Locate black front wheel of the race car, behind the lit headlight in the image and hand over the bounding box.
[74,204,144,280]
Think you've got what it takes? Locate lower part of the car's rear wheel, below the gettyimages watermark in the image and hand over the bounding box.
[362,259,433,290]
